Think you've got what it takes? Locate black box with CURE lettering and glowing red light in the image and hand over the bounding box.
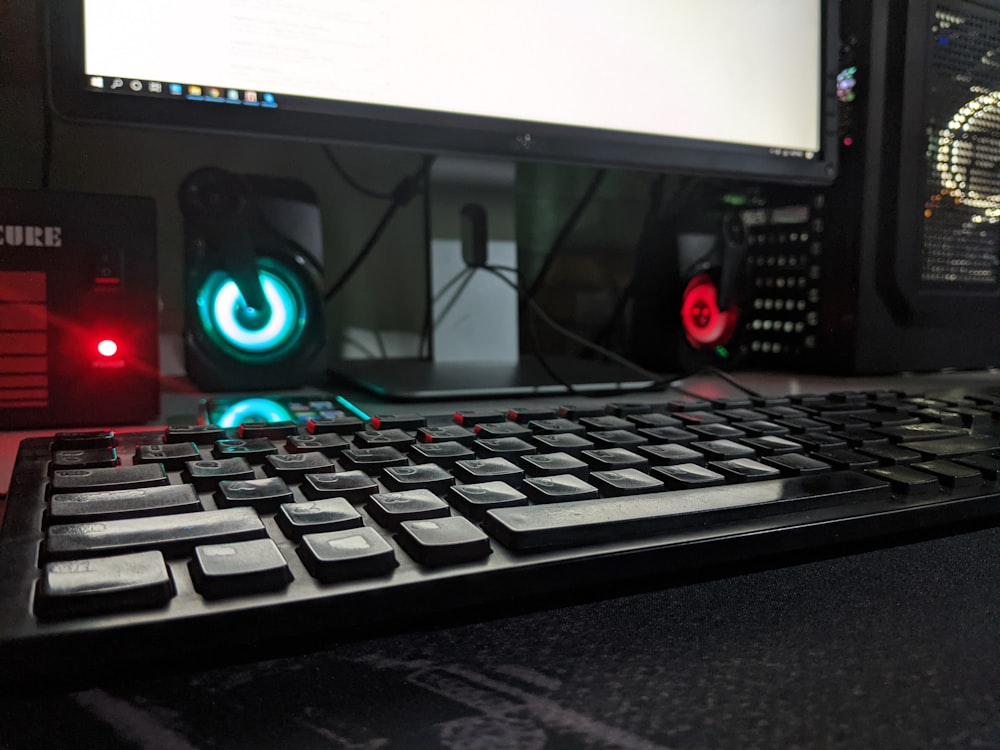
[0,190,160,429]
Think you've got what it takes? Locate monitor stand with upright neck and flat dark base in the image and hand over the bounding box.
[336,158,652,400]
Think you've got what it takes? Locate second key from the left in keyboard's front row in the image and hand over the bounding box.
[188,539,292,599]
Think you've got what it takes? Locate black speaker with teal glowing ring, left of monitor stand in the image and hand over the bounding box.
[179,167,326,391]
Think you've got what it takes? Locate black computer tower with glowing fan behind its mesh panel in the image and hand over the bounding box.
[816,0,1000,373]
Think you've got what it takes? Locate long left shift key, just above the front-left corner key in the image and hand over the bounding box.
[44,508,267,560]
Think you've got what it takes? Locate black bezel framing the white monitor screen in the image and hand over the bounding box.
[45,0,839,185]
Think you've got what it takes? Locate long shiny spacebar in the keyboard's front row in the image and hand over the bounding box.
[483,471,891,550]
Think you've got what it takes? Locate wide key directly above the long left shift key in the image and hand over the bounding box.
[46,484,202,524]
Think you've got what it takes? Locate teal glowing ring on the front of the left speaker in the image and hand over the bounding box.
[196,258,308,363]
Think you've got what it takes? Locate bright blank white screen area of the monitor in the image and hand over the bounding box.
[85,0,822,153]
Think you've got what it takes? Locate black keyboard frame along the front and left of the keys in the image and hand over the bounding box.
[0,400,1000,683]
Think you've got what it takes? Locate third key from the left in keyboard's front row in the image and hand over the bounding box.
[298,526,399,583]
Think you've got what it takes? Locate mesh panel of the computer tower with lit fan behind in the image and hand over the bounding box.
[920,2,1000,290]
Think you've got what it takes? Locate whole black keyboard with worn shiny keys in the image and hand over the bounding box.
[0,391,1000,680]
